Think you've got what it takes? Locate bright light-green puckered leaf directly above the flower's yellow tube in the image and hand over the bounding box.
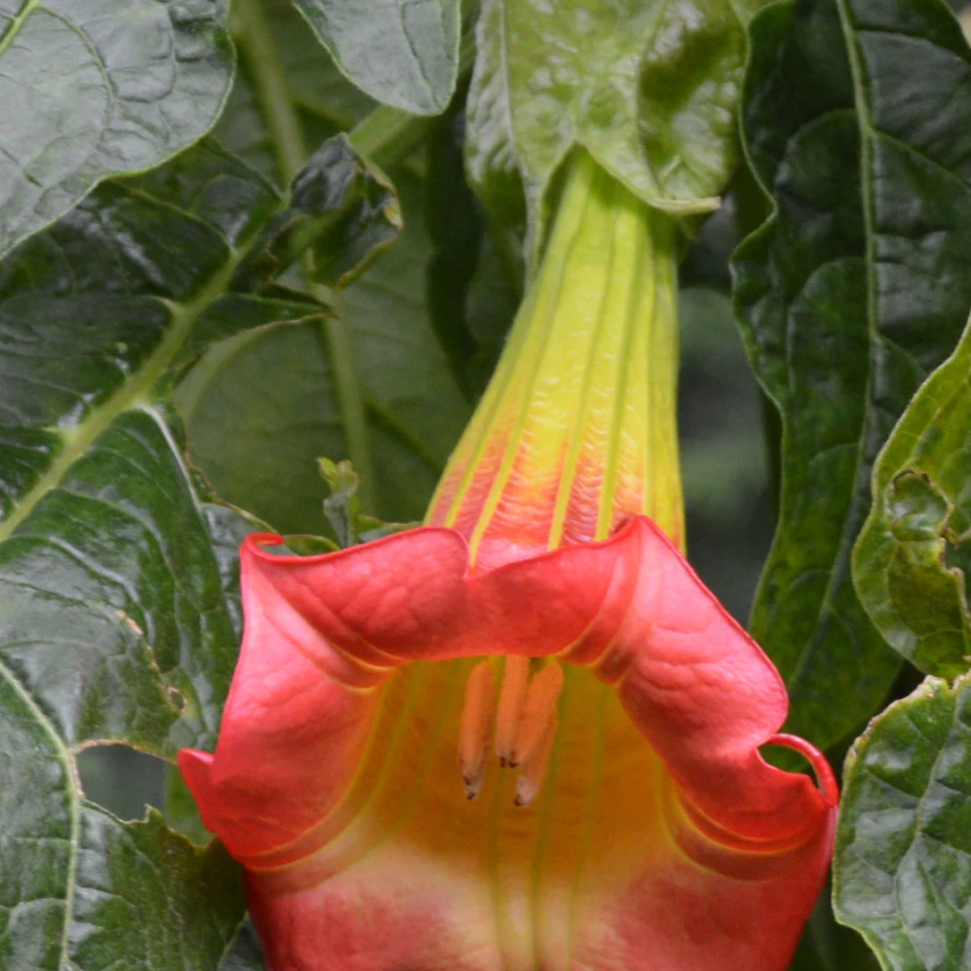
[466,0,756,251]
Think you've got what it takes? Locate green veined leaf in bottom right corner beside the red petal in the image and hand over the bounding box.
[834,678,971,971]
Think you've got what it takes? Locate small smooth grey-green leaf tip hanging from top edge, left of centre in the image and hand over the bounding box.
[294,0,461,115]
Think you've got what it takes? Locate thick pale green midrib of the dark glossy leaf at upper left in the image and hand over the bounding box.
[0,246,254,543]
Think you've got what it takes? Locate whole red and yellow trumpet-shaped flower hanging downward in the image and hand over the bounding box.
[180,153,836,971]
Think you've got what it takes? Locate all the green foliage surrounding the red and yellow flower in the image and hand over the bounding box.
[0,0,971,971]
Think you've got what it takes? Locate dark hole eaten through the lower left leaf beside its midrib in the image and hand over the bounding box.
[78,745,165,819]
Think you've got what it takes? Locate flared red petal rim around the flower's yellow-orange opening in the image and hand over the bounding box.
[180,517,836,971]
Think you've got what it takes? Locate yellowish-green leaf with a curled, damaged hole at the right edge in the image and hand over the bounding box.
[853,316,971,678]
